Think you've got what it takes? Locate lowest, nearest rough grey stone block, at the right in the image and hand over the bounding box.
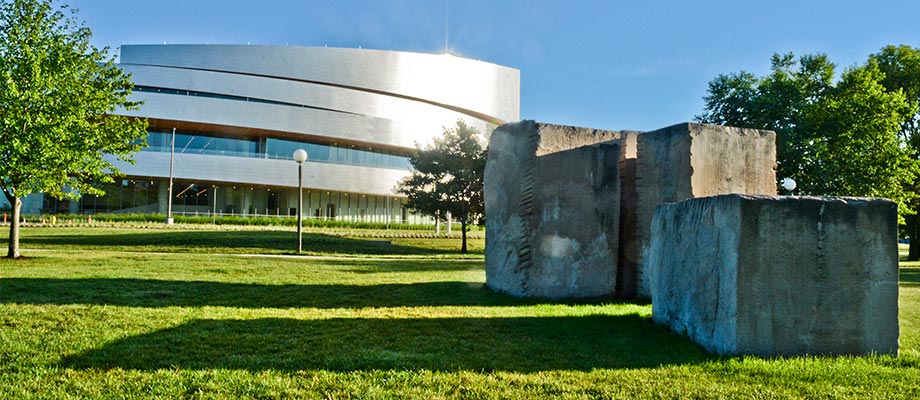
[646,195,898,356]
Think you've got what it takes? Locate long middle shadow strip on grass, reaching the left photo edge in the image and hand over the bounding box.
[0,278,545,308]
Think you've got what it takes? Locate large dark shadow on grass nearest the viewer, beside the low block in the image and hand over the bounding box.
[61,315,713,372]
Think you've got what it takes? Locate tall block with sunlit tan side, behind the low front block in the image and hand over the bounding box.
[619,123,776,297]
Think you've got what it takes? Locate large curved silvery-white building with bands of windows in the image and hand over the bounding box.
[30,45,520,222]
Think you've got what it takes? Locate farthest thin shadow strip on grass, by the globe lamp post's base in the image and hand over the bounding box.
[20,230,482,255]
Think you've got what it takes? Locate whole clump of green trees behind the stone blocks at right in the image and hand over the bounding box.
[697,54,918,220]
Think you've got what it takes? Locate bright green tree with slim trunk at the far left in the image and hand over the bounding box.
[0,0,147,258]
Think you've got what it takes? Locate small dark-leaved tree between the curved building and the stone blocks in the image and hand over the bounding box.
[398,121,486,253]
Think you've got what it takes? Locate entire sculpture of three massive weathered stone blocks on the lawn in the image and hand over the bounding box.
[484,121,898,356]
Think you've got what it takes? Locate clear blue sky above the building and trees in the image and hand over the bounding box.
[67,0,920,130]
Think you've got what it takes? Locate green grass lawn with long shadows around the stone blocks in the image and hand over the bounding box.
[0,228,920,399]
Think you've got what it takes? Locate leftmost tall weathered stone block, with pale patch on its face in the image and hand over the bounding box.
[484,121,620,298]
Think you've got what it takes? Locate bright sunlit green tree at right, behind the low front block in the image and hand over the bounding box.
[803,62,917,206]
